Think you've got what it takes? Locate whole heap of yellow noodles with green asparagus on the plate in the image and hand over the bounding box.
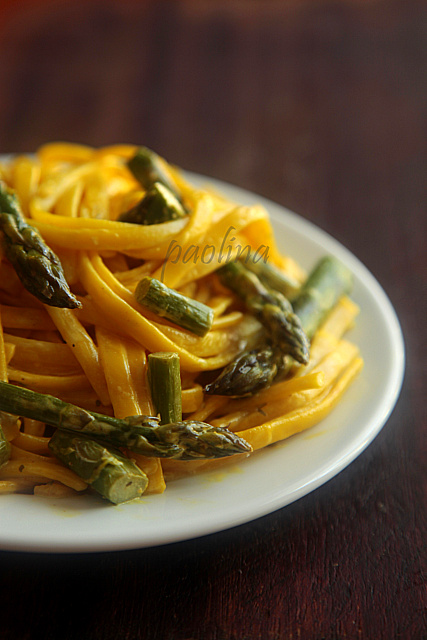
[0,143,363,503]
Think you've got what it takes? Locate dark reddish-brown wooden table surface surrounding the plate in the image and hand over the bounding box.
[0,0,427,640]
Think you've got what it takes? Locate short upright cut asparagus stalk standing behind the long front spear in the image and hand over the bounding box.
[148,352,182,424]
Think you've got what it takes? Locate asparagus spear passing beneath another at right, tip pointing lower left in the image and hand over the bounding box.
[205,256,352,396]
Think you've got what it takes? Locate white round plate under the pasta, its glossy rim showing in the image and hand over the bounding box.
[0,175,404,553]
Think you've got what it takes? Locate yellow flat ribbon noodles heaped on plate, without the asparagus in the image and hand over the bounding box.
[0,142,363,498]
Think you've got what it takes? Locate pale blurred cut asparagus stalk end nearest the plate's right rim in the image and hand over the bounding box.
[292,256,353,338]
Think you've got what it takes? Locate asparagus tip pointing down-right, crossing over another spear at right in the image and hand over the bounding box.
[218,262,310,364]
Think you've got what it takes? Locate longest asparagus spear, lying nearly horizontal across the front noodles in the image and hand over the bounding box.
[0,382,251,460]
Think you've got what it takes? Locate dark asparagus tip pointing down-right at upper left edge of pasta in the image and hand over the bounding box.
[0,182,81,309]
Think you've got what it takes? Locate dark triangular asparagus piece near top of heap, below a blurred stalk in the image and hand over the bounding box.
[118,182,187,225]
